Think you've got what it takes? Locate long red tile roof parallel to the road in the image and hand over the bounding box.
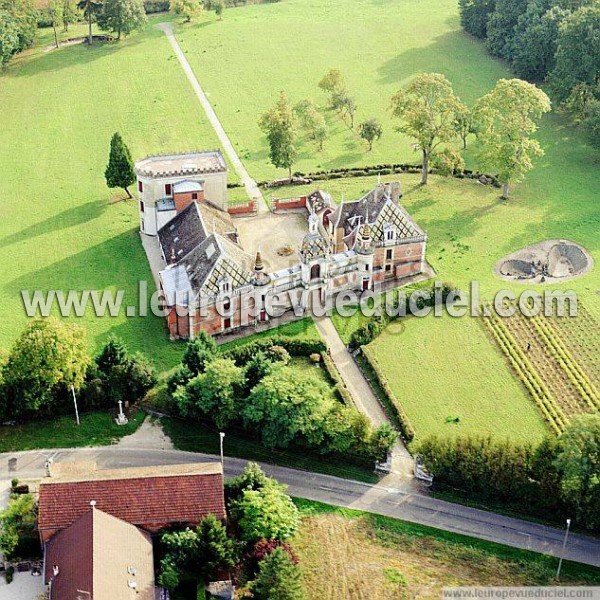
[38,463,225,541]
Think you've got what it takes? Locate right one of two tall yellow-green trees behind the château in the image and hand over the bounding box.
[474,79,551,198]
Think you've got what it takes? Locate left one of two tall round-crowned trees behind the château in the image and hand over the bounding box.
[391,73,464,184]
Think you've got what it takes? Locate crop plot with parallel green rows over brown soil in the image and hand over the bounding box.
[482,304,600,433]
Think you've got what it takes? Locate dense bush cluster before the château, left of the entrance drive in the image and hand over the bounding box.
[167,333,396,461]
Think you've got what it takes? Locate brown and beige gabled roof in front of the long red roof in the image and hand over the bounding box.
[45,507,154,600]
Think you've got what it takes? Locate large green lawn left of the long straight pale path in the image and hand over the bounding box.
[0,15,235,369]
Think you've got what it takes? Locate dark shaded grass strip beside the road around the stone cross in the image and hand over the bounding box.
[0,411,145,452]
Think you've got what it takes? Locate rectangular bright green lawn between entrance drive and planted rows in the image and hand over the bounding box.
[370,315,547,441]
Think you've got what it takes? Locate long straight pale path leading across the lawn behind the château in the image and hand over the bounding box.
[157,23,269,212]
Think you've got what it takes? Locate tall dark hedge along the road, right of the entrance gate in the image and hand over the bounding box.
[415,414,600,531]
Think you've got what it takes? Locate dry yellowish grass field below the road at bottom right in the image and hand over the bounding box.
[292,499,600,600]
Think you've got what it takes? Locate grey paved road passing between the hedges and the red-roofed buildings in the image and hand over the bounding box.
[0,446,600,567]
